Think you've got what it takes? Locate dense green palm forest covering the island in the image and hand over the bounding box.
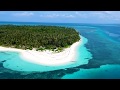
[0,25,80,51]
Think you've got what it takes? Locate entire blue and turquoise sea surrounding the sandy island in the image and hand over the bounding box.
[0,22,120,79]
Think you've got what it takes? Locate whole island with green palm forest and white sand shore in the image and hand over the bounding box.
[0,25,81,66]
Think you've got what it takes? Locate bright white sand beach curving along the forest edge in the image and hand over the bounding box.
[0,39,82,66]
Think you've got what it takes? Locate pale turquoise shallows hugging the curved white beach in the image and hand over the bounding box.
[0,36,92,72]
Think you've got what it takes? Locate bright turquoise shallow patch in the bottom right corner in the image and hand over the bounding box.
[62,65,120,79]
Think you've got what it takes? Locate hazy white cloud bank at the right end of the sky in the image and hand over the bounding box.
[74,11,120,21]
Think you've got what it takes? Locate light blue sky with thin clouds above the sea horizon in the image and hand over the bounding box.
[0,11,120,24]
